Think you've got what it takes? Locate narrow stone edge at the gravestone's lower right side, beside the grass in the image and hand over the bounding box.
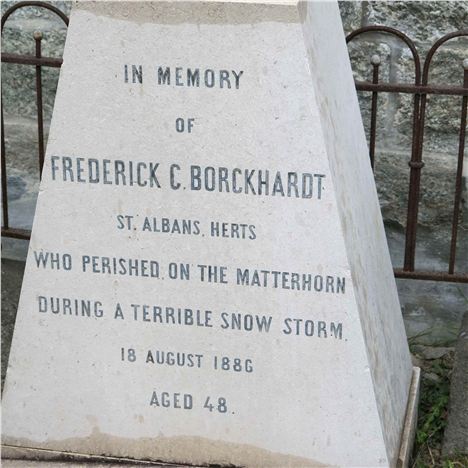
[396,367,421,468]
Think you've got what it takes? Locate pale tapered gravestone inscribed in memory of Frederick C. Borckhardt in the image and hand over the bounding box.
[3,1,417,466]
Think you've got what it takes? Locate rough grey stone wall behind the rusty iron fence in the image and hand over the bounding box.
[1,0,468,342]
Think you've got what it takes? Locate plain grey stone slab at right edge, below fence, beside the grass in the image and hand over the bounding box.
[443,312,468,456]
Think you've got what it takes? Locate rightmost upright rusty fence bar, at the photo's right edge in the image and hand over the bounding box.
[448,59,468,275]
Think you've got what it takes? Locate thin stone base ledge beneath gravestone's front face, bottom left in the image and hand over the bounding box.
[1,444,194,468]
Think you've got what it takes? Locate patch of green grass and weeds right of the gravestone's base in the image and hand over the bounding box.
[412,352,468,468]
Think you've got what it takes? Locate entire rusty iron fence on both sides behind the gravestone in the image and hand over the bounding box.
[1,1,468,283]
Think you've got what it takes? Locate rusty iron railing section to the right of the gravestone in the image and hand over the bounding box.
[346,26,468,283]
